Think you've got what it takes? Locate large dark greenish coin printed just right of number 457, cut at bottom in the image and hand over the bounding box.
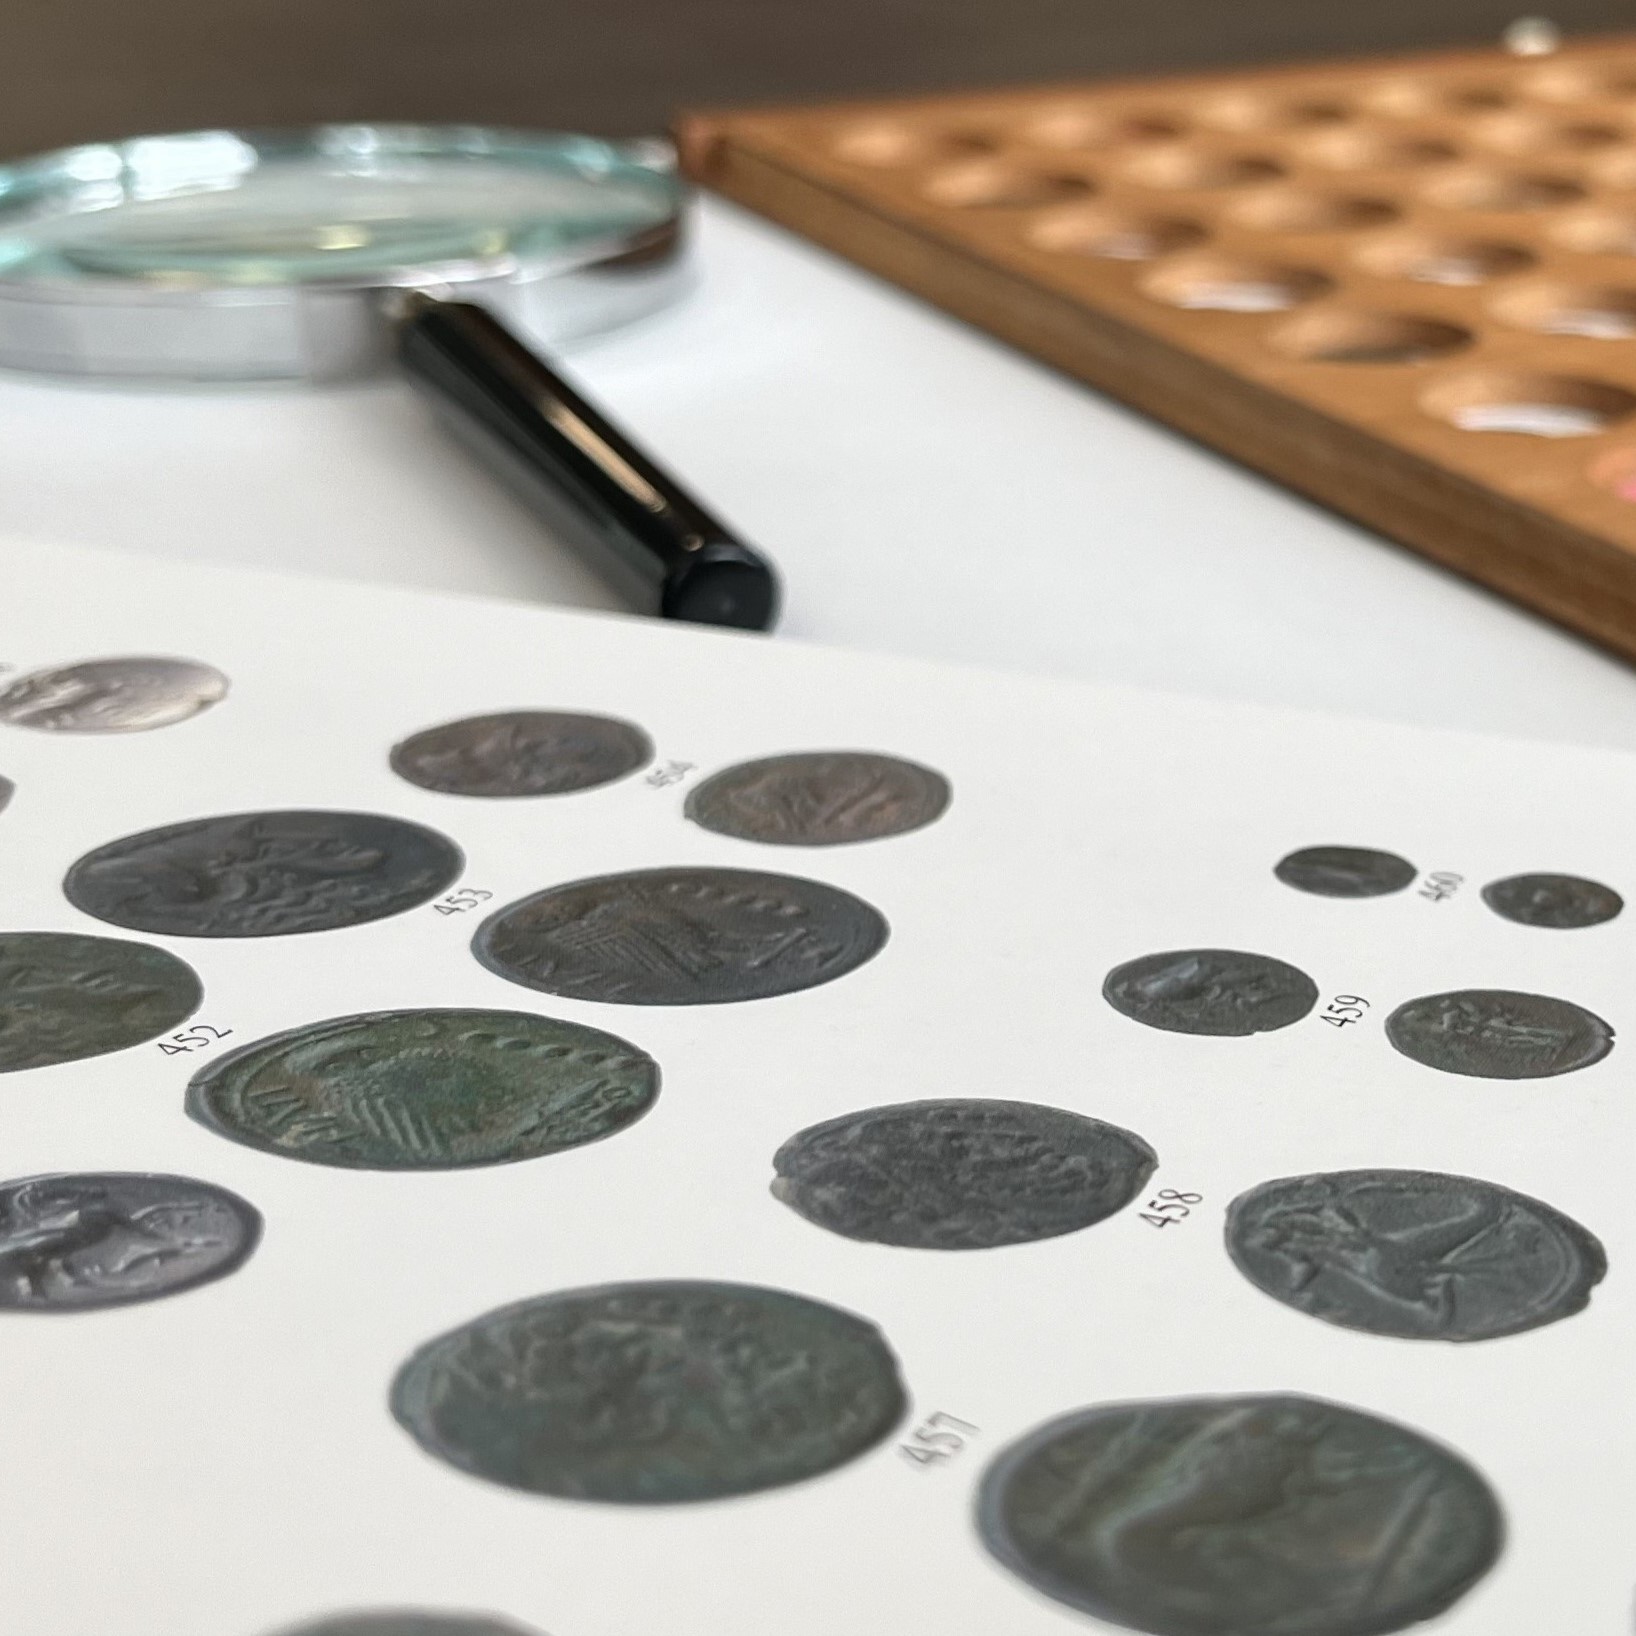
[978,1396,1503,1636]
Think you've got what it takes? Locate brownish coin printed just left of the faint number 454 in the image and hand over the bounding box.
[391,710,653,800]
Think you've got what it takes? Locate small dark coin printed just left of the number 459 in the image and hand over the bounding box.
[1103,949,1319,1037]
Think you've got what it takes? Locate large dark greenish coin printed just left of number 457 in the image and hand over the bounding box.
[393,1283,905,1505]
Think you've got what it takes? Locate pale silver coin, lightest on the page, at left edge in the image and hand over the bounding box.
[0,658,227,733]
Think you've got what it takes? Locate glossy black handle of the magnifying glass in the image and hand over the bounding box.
[396,291,779,630]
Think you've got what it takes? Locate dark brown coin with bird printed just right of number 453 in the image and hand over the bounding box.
[471,869,887,1006]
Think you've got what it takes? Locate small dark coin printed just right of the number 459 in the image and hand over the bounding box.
[1386,988,1613,1080]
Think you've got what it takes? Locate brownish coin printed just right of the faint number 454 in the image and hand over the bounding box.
[682,749,949,846]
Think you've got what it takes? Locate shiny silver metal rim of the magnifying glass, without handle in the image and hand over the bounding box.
[0,124,689,384]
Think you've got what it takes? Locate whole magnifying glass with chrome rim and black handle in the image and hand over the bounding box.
[0,124,777,630]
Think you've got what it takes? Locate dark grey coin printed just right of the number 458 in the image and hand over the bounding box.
[1227,1170,1608,1340]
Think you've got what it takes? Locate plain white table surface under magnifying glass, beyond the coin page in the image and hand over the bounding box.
[0,189,1636,748]
